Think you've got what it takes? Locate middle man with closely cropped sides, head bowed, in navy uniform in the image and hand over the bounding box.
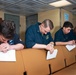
[25,19,54,53]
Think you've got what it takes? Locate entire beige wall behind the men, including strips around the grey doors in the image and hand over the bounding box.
[0,9,76,41]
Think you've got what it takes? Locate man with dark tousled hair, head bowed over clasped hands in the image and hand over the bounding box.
[0,21,24,52]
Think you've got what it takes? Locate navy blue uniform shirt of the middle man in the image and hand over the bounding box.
[25,23,53,48]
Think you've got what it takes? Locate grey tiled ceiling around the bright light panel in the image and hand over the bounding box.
[0,0,76,16]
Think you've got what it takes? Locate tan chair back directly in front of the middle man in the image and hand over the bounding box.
[21,49,49,75]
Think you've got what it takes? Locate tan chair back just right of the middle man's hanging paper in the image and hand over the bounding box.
[49,46,65,73]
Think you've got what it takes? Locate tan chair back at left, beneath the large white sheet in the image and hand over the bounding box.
[0,51,24,75]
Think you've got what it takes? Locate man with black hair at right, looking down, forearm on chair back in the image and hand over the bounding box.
[54,21,75,45]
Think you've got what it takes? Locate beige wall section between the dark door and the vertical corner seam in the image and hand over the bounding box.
[38,9,60,37]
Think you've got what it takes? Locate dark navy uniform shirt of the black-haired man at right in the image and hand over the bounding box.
[54,28,74,42]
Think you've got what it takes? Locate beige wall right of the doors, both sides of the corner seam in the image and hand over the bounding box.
[38,8,76,37]
